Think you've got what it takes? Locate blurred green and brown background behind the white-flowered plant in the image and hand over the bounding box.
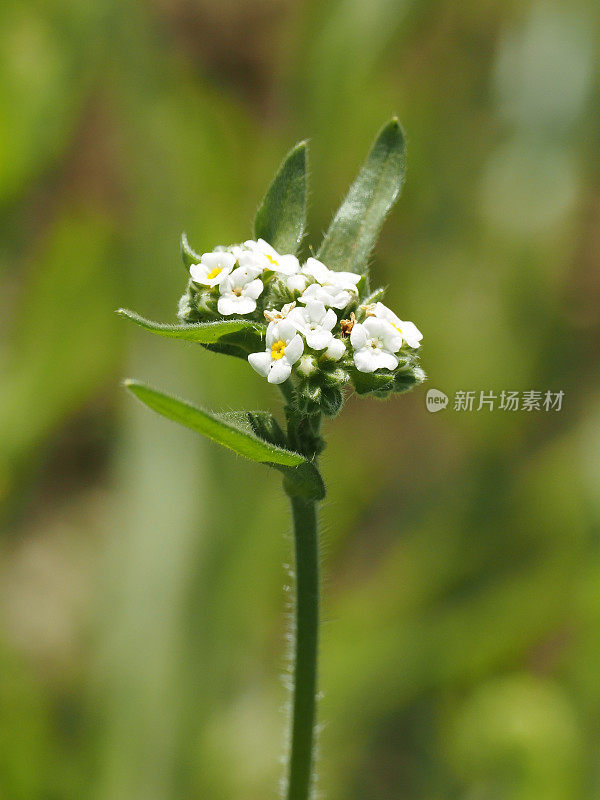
[0,0,600,800]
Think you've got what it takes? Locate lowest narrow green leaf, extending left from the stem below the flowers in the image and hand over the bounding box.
[125,380,307,467]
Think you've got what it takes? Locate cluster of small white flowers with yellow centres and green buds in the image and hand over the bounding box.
[179,239,424,414]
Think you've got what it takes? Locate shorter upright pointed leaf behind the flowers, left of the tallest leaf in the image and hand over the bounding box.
[254,142,306,254]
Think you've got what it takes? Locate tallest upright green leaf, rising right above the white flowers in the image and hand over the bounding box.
[317,118,406,274]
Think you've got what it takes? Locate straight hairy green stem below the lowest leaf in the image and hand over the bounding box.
[287,497,319,800]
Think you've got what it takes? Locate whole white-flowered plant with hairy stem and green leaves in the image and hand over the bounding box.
[118,119,425,800]
